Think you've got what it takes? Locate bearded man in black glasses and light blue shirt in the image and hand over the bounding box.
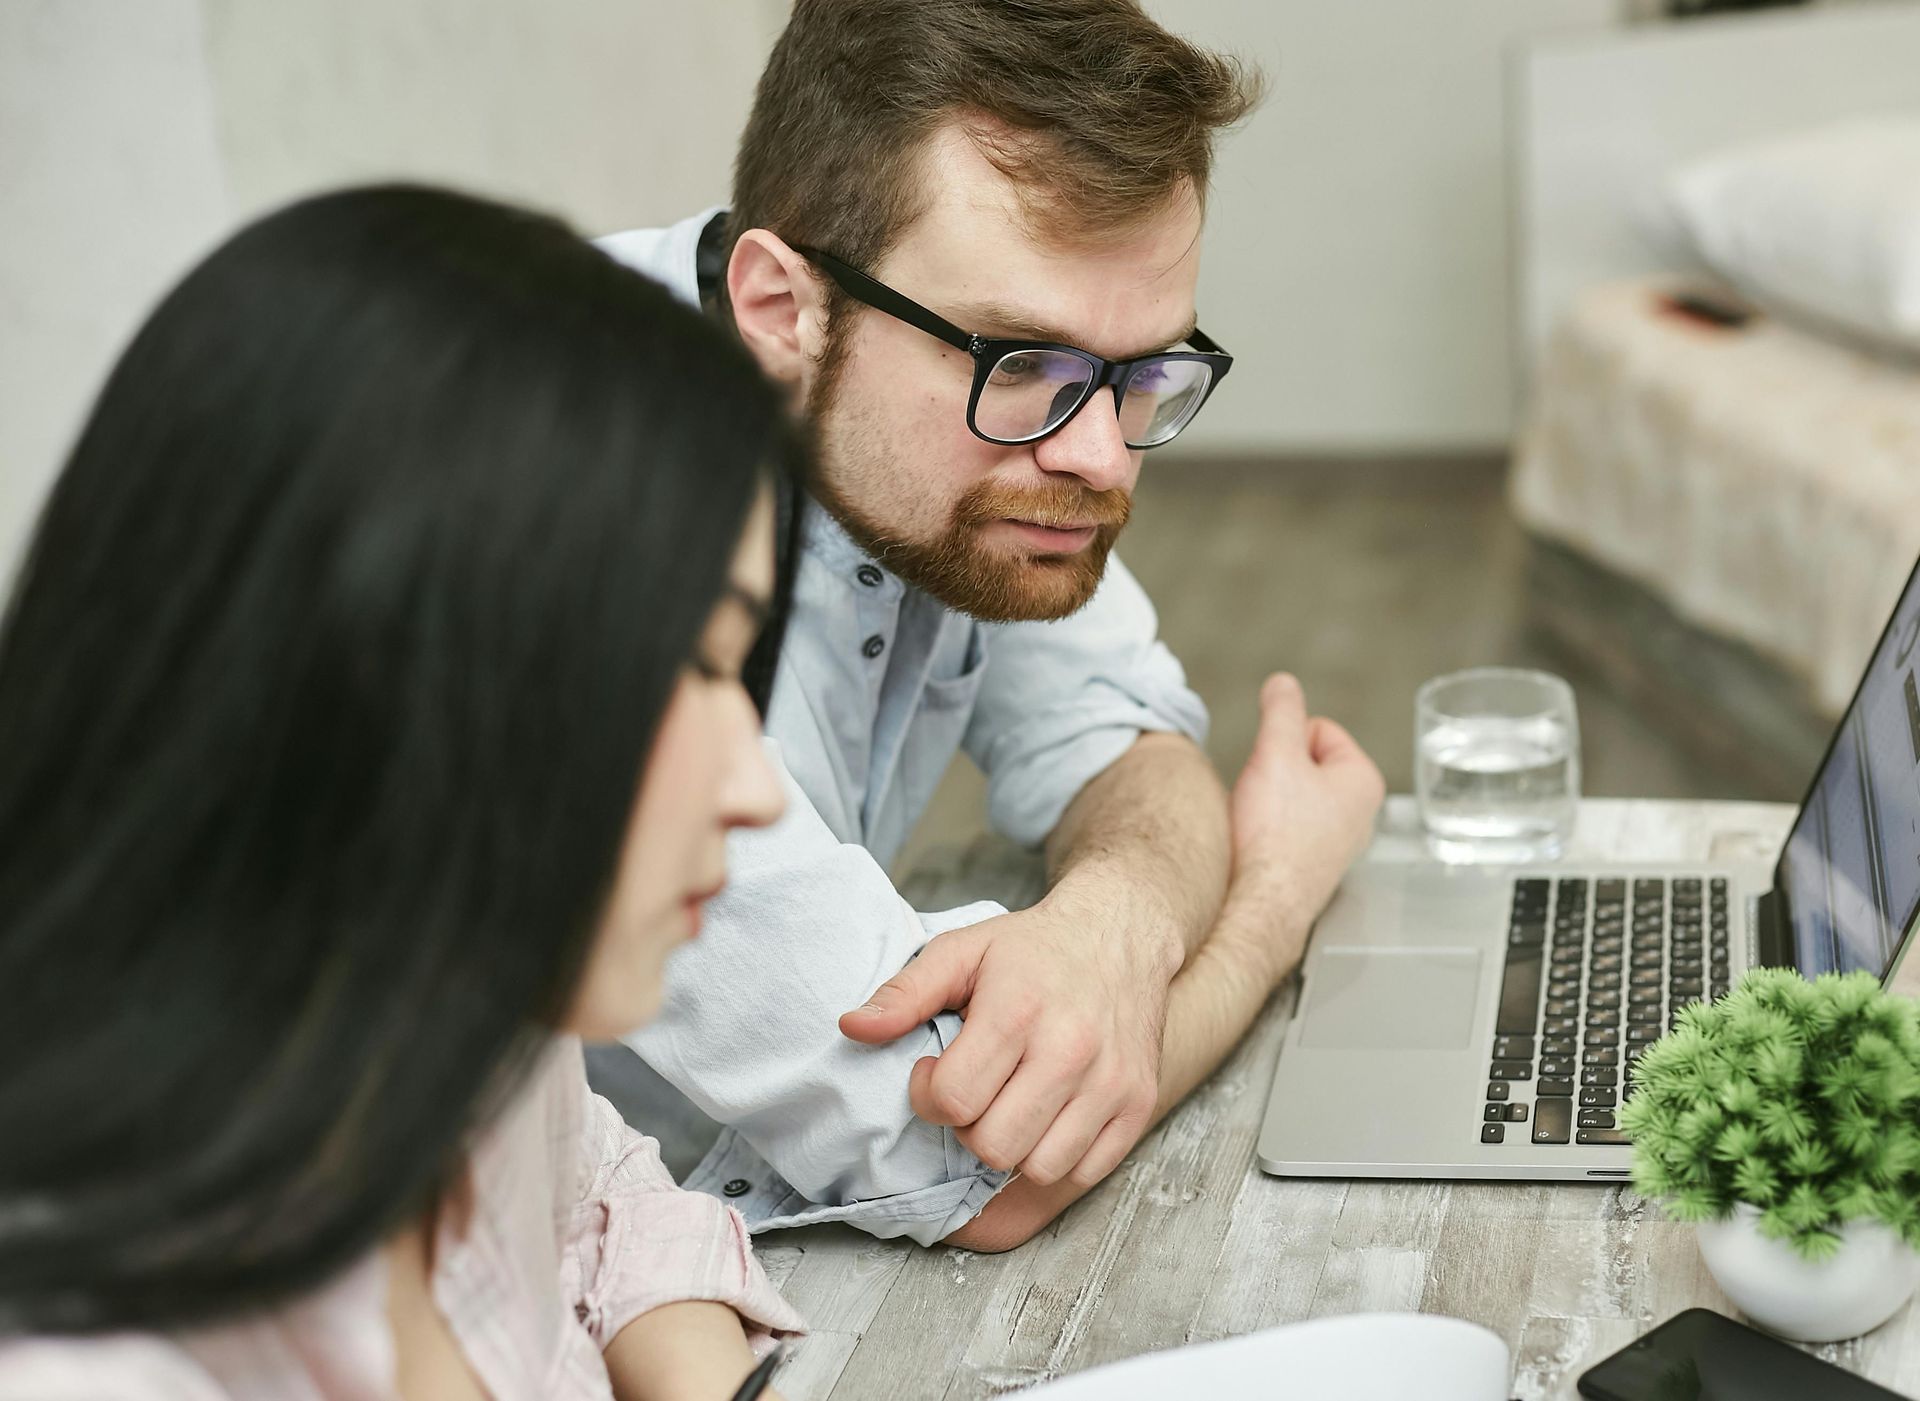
[603,0,1380,1249]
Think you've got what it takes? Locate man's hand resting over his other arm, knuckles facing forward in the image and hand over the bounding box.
[839,887,1177,1188]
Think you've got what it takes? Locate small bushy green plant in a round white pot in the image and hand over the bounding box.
[1620,969,1920,1342]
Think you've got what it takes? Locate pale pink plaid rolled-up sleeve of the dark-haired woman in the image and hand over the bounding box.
[561,1075,804,1351]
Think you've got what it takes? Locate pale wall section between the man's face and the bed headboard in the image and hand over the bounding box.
[1148,0,1619,453]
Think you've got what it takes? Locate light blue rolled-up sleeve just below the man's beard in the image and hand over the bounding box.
[964,555,1208,846]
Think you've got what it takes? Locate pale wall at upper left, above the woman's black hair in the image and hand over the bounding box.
[0,0,785,593]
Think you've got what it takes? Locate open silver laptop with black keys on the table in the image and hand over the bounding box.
[1256,552,1920,1180]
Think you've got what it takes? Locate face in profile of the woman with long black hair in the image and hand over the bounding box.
[563,489,785,1040]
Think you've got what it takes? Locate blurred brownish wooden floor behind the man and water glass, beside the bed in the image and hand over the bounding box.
[897,459,1811,871]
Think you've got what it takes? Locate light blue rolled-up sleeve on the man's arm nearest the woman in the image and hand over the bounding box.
[628,741,1006,1246]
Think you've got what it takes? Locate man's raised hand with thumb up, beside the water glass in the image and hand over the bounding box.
[1227,672,1386,983]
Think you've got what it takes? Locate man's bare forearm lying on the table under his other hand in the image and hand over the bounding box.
[947,882,1311,1251]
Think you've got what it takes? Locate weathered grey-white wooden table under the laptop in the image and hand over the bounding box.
[760,798,1920,1401]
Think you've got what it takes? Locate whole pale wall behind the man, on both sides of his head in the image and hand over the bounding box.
[0,0,1622,583]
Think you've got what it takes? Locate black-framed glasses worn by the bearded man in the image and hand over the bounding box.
[793,244,1233,449]
